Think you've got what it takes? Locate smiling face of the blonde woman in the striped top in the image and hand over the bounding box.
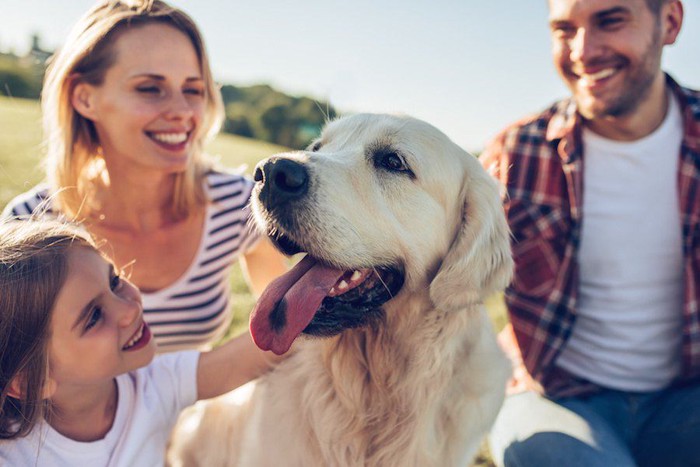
[72,23,207,177]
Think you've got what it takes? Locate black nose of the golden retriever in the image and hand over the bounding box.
[254,157,309,209]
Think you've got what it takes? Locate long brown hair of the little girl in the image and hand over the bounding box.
[0,220,97,439]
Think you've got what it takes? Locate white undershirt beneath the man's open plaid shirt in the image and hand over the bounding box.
[556,93,683,391]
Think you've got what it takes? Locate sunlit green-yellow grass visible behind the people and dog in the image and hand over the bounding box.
[0,96,506,467]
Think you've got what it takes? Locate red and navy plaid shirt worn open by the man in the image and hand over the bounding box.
[481,76,700,397]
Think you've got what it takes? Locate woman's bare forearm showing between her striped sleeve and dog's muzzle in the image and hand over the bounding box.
[241,237,289,297]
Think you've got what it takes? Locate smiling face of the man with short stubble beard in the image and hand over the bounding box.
[549,0,670,120]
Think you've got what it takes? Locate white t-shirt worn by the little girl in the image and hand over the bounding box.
[0,351,199,467]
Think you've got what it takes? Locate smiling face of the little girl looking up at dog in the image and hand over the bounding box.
[49,247,155,391]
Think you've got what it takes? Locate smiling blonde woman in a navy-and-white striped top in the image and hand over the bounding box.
[5,0,286,351]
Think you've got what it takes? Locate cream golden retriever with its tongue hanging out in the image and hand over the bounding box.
[170,114,513,467]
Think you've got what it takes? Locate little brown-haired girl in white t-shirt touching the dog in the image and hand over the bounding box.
[0,221,272,466]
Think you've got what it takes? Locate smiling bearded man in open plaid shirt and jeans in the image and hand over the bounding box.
[482,0,700,467]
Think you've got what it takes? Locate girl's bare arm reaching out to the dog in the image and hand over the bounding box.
[197,332,290,400]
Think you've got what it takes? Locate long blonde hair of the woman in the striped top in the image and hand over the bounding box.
[42,0,224,219]
